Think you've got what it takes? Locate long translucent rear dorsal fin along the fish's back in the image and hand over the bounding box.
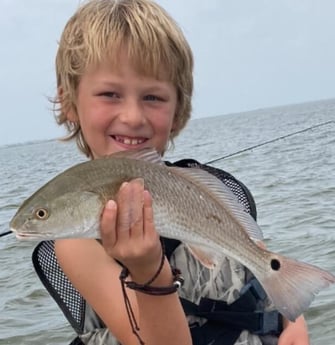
[168,167,263,241]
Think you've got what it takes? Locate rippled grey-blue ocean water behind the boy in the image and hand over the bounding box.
[0,100,335,345]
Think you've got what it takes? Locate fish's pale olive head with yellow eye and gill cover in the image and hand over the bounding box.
[10,191,103,240]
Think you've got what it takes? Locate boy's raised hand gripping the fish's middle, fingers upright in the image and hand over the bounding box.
[101,179,162,283]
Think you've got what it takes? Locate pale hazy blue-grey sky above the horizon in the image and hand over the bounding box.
[0,0,335,145]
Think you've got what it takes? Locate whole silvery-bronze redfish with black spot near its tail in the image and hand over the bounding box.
[10,149,335,321]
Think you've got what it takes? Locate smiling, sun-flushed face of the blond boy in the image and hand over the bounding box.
[68,59,177,158]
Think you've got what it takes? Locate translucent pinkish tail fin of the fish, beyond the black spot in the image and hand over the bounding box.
[254,254,335,321]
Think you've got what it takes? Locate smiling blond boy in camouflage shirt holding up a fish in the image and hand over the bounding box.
[34,0,308,345]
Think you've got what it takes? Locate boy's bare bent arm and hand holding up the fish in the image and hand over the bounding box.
[55,182,192,345]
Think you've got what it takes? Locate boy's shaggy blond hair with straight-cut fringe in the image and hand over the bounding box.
[54,0,193,157]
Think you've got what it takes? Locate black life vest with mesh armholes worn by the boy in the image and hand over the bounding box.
[32,159,282,345]
